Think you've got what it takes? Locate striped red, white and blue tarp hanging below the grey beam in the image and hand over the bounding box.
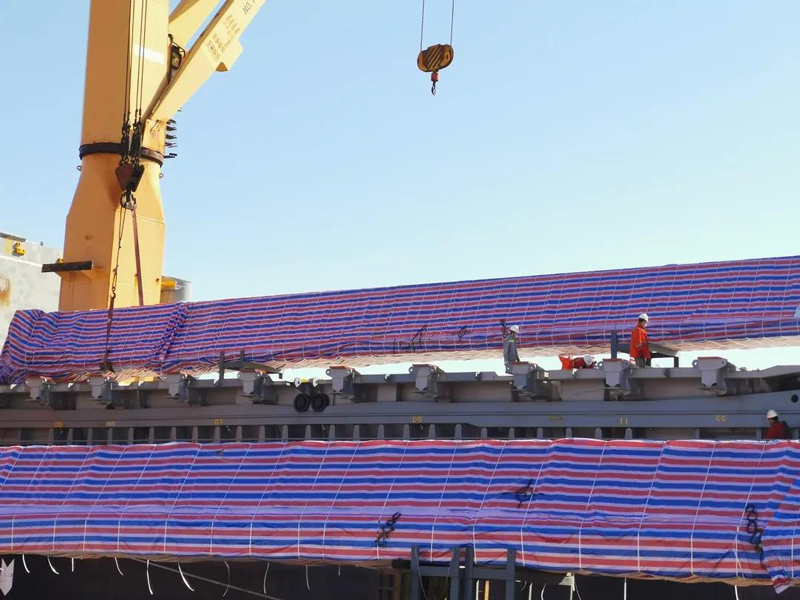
[0,439,800,589]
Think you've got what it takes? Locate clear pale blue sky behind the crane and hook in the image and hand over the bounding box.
[0,0,800,366]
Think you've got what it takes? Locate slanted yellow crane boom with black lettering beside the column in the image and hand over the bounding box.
[148,0,264,122]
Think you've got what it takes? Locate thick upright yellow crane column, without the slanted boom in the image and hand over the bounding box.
[59,0,170,310]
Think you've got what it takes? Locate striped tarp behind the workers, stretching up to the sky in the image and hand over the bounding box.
[0,256,800,382]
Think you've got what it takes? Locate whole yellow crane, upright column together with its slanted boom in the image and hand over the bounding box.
[57,0,264,311]
